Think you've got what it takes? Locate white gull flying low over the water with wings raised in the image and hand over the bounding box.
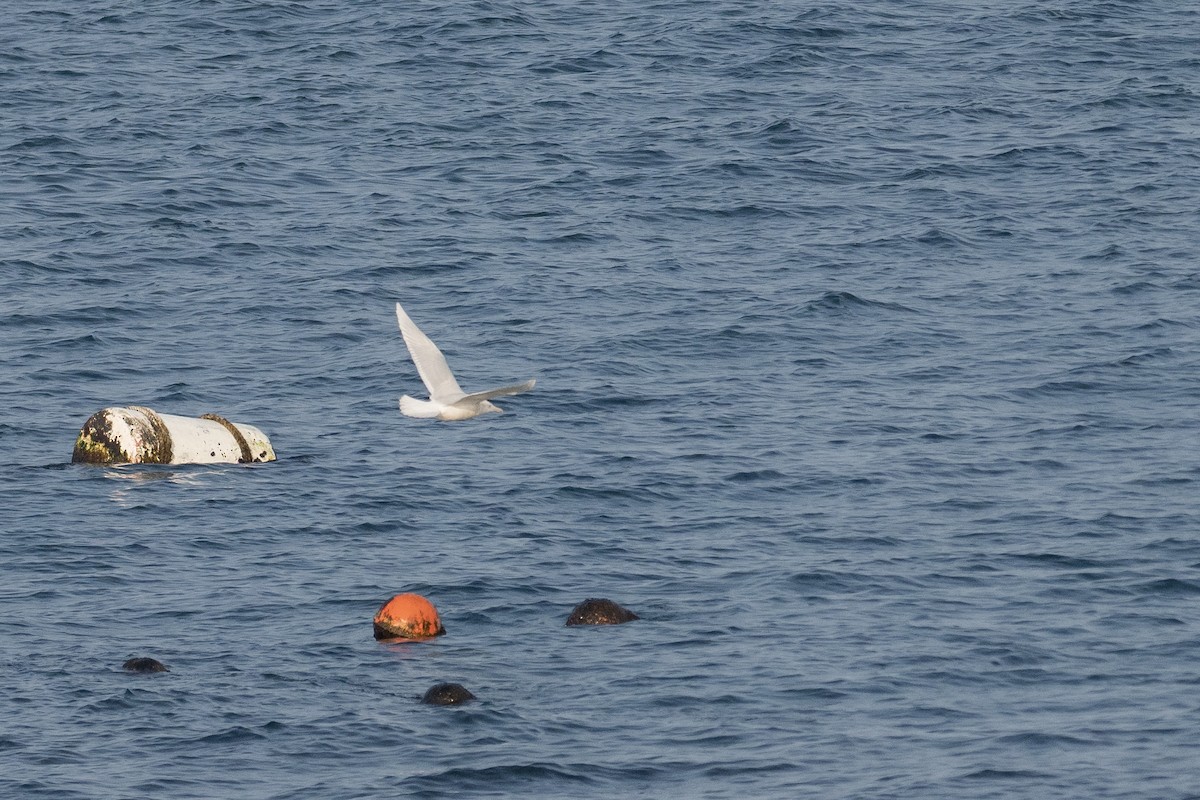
[396,302,536,420]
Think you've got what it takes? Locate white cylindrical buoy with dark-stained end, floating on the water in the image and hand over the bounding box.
[71,405,275,464]
